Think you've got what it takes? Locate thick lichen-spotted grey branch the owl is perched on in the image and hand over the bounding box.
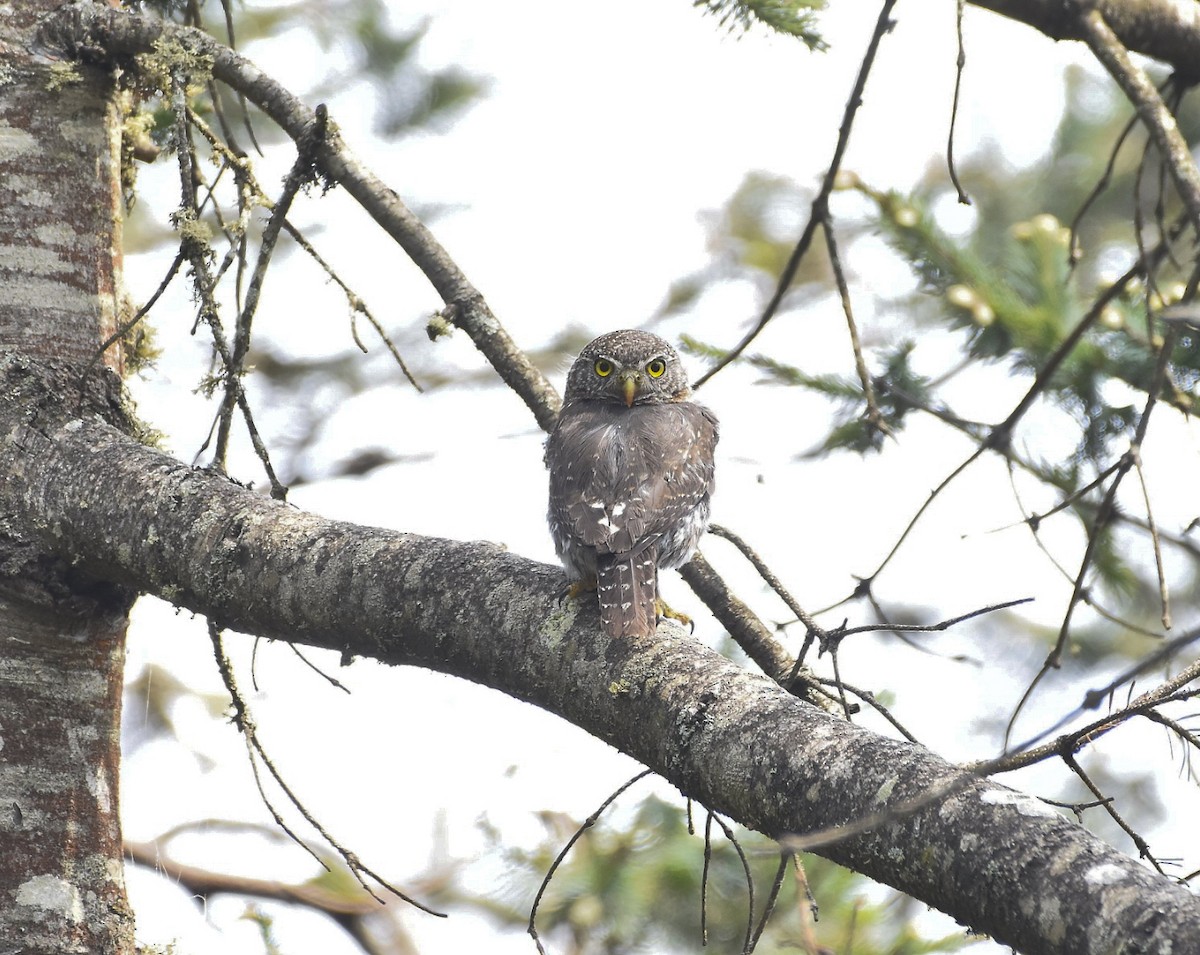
[0,356,1200,955]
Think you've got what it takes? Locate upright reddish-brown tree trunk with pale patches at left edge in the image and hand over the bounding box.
[0,0,133,955]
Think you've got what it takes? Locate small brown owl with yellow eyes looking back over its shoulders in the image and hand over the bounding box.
[546,330,718,637]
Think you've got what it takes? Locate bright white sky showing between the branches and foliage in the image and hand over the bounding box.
[122,0,1196,955]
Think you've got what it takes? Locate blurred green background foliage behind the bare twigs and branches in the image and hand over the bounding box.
[114,0,1200,955]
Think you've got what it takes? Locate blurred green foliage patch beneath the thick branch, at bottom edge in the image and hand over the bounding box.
[461,797,967,955]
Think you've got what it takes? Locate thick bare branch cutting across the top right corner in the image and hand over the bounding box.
[970,0,1200,79]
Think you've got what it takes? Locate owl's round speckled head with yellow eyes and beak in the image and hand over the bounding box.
[565,329,691,408]
